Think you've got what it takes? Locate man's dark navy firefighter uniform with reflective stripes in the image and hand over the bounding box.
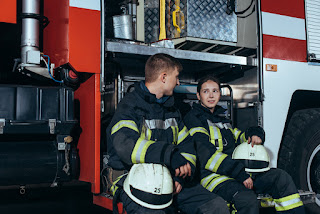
[107,82,227,214]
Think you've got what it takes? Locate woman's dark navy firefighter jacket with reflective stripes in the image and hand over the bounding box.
[184,103,264,191]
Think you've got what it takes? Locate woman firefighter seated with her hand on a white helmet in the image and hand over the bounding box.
[184,75,305,214]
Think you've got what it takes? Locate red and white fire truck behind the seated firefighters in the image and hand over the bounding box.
[0,0,320,213]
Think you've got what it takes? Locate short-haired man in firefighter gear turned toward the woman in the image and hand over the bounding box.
[107,54,228,214]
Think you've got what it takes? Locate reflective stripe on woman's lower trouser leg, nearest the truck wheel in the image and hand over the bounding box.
[274,193,303,211]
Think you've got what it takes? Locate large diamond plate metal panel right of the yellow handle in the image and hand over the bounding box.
[187,0,237,42]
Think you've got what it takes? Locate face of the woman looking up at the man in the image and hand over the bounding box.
[197,80,221,112]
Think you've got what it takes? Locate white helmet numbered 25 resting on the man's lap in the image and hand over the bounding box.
[123,163,173,209]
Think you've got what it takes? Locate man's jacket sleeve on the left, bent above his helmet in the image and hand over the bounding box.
[109,99,174,166]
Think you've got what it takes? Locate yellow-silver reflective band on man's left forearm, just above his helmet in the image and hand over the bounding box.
[131,137,154,163]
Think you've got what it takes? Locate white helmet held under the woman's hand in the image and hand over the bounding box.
[232,142,270,172]
